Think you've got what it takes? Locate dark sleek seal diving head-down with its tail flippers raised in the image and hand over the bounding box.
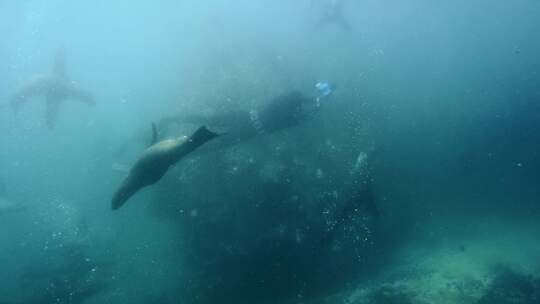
[111,125,219,210]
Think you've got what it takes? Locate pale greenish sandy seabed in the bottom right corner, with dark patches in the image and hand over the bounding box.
[322,220,540,304]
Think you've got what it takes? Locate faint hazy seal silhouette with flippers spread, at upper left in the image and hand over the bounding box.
[10,50,95,129]
